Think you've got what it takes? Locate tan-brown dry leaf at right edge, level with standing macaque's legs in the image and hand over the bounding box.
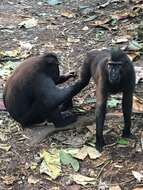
[133,96,143,113]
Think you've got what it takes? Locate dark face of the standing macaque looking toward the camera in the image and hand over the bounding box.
[107,61,122,84]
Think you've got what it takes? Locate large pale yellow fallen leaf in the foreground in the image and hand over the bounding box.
[40,150,61,179]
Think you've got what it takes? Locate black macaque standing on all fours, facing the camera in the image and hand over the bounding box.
[64,47,135,151]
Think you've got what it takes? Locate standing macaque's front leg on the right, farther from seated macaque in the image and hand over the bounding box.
[122,91,133,137]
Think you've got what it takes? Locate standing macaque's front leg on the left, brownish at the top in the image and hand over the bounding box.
[96,85,107,151]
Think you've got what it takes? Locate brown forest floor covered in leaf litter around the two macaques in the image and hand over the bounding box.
[0,0,143,190]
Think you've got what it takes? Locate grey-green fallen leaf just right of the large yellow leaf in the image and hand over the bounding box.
[60,151,79,171]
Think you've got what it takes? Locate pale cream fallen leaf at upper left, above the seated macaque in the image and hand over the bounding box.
[19,18,38,28]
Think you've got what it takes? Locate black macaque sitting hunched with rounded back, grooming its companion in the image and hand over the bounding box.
[3,53,76,127]
